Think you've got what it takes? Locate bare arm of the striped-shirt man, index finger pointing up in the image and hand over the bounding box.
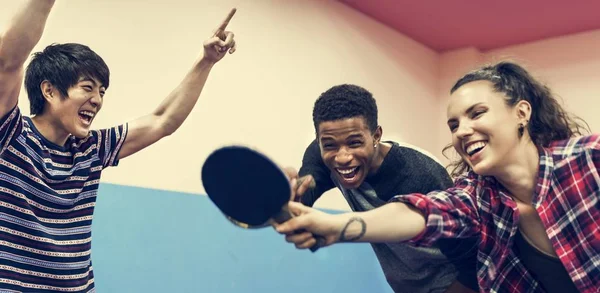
[119,9,236,159]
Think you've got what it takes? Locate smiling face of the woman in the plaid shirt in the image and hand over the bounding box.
[447,81,526,175]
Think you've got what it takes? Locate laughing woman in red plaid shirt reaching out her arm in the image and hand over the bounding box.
[276,62,600,293]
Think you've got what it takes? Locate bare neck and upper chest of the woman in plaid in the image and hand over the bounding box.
[494,137,540,204]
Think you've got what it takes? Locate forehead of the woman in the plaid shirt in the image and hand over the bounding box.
[447,80,504,118]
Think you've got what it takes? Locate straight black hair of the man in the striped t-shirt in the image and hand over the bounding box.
[25,43,110,115]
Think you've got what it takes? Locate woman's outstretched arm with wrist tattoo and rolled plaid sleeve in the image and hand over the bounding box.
[275,176,479,249]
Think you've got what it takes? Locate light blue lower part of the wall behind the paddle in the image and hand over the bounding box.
[92,184,392,293]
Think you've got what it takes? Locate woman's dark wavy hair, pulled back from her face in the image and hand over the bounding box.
[442,61,590,177]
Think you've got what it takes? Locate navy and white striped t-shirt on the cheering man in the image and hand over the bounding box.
[0,107,127,292]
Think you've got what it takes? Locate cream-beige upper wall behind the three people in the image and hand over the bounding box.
[0,0,600,209]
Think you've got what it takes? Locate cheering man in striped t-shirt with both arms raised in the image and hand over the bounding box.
[0,0,235,292]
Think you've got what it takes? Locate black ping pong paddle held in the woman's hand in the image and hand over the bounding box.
[201,145,325,252]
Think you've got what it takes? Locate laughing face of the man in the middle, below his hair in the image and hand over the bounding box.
[318,116,381,189]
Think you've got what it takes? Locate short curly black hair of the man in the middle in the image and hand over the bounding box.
[313,84,378,133]
